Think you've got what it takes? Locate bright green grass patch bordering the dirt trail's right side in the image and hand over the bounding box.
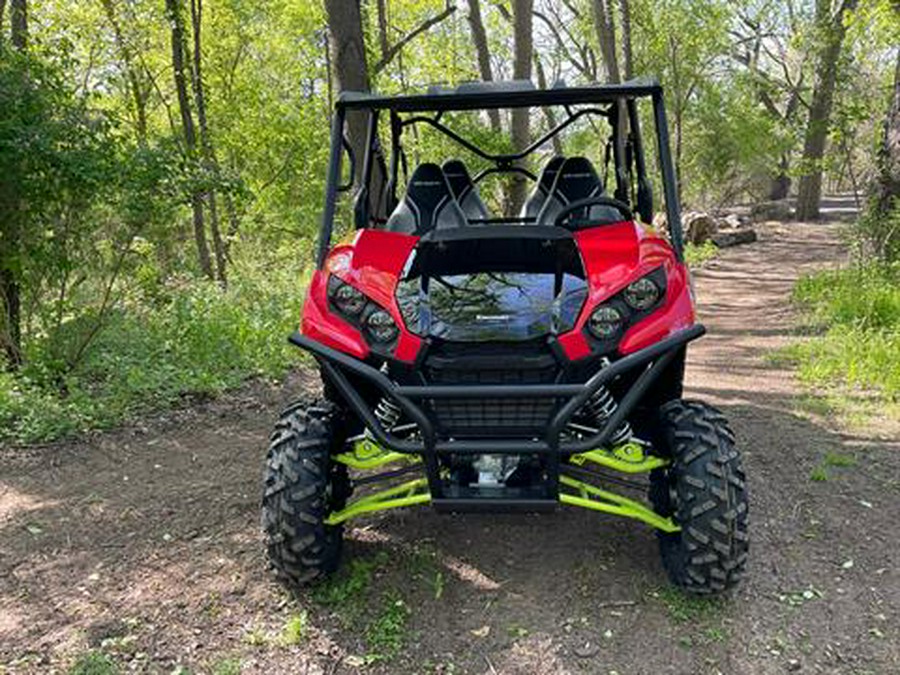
[782,263,900,409]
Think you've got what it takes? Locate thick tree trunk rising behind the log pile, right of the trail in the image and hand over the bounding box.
[797,0,857,220]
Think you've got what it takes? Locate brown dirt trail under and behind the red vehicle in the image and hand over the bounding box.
[0,225,900,675]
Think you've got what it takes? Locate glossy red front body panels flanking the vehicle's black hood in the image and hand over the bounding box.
[301,221,694,363]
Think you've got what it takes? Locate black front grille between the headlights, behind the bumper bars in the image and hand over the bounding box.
[424,341,559,438]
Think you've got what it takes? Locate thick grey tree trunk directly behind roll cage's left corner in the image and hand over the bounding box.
[325,0,370,187]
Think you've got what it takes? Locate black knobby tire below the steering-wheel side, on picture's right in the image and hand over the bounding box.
[650,400,749,594]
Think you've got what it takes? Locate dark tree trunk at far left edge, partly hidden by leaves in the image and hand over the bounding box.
[0,0,28,370]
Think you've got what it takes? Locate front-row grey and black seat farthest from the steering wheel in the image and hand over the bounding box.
[386,163,466,234]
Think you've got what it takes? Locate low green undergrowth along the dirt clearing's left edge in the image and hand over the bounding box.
[0,267,303,443]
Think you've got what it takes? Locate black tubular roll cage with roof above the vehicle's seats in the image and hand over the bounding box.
[316,78,684,268]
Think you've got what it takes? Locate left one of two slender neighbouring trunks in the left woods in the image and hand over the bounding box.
[166,0,215,279]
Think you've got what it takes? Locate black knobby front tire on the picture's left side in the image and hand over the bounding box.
[262,402,349,586]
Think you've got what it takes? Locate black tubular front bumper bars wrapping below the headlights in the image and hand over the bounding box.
[289,324,706,456]
